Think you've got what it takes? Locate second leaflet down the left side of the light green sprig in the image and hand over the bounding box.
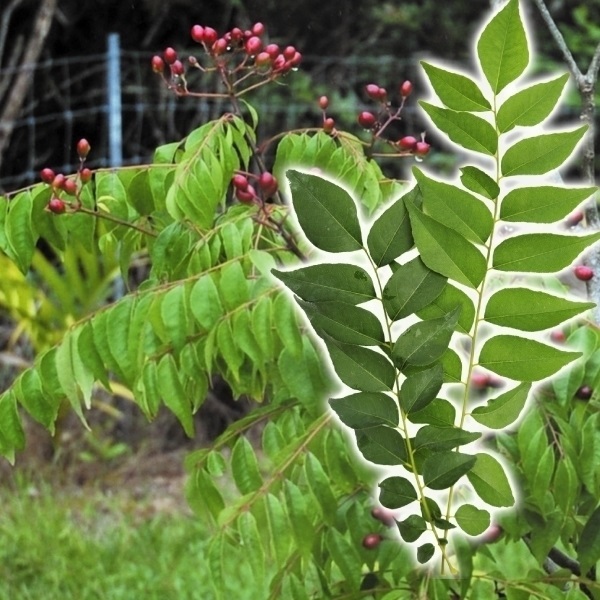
[419,100,498,156]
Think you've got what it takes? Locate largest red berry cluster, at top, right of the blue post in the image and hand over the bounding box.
[152,23,302,97]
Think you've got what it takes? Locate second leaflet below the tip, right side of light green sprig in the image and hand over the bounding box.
[500,125,587,177]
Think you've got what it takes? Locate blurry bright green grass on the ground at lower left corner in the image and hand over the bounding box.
[0,474,252,600]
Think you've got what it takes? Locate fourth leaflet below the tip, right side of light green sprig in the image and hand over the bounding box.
[493,233,600,273]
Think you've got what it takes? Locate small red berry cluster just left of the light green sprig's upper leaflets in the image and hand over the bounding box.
[342,80,431,157]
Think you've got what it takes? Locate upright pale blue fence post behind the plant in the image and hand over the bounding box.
[106,33,123,167]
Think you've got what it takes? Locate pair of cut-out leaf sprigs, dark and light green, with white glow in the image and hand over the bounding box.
[273,0,600,572]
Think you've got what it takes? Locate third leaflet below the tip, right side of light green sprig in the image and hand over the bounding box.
[500,185,596,223]
